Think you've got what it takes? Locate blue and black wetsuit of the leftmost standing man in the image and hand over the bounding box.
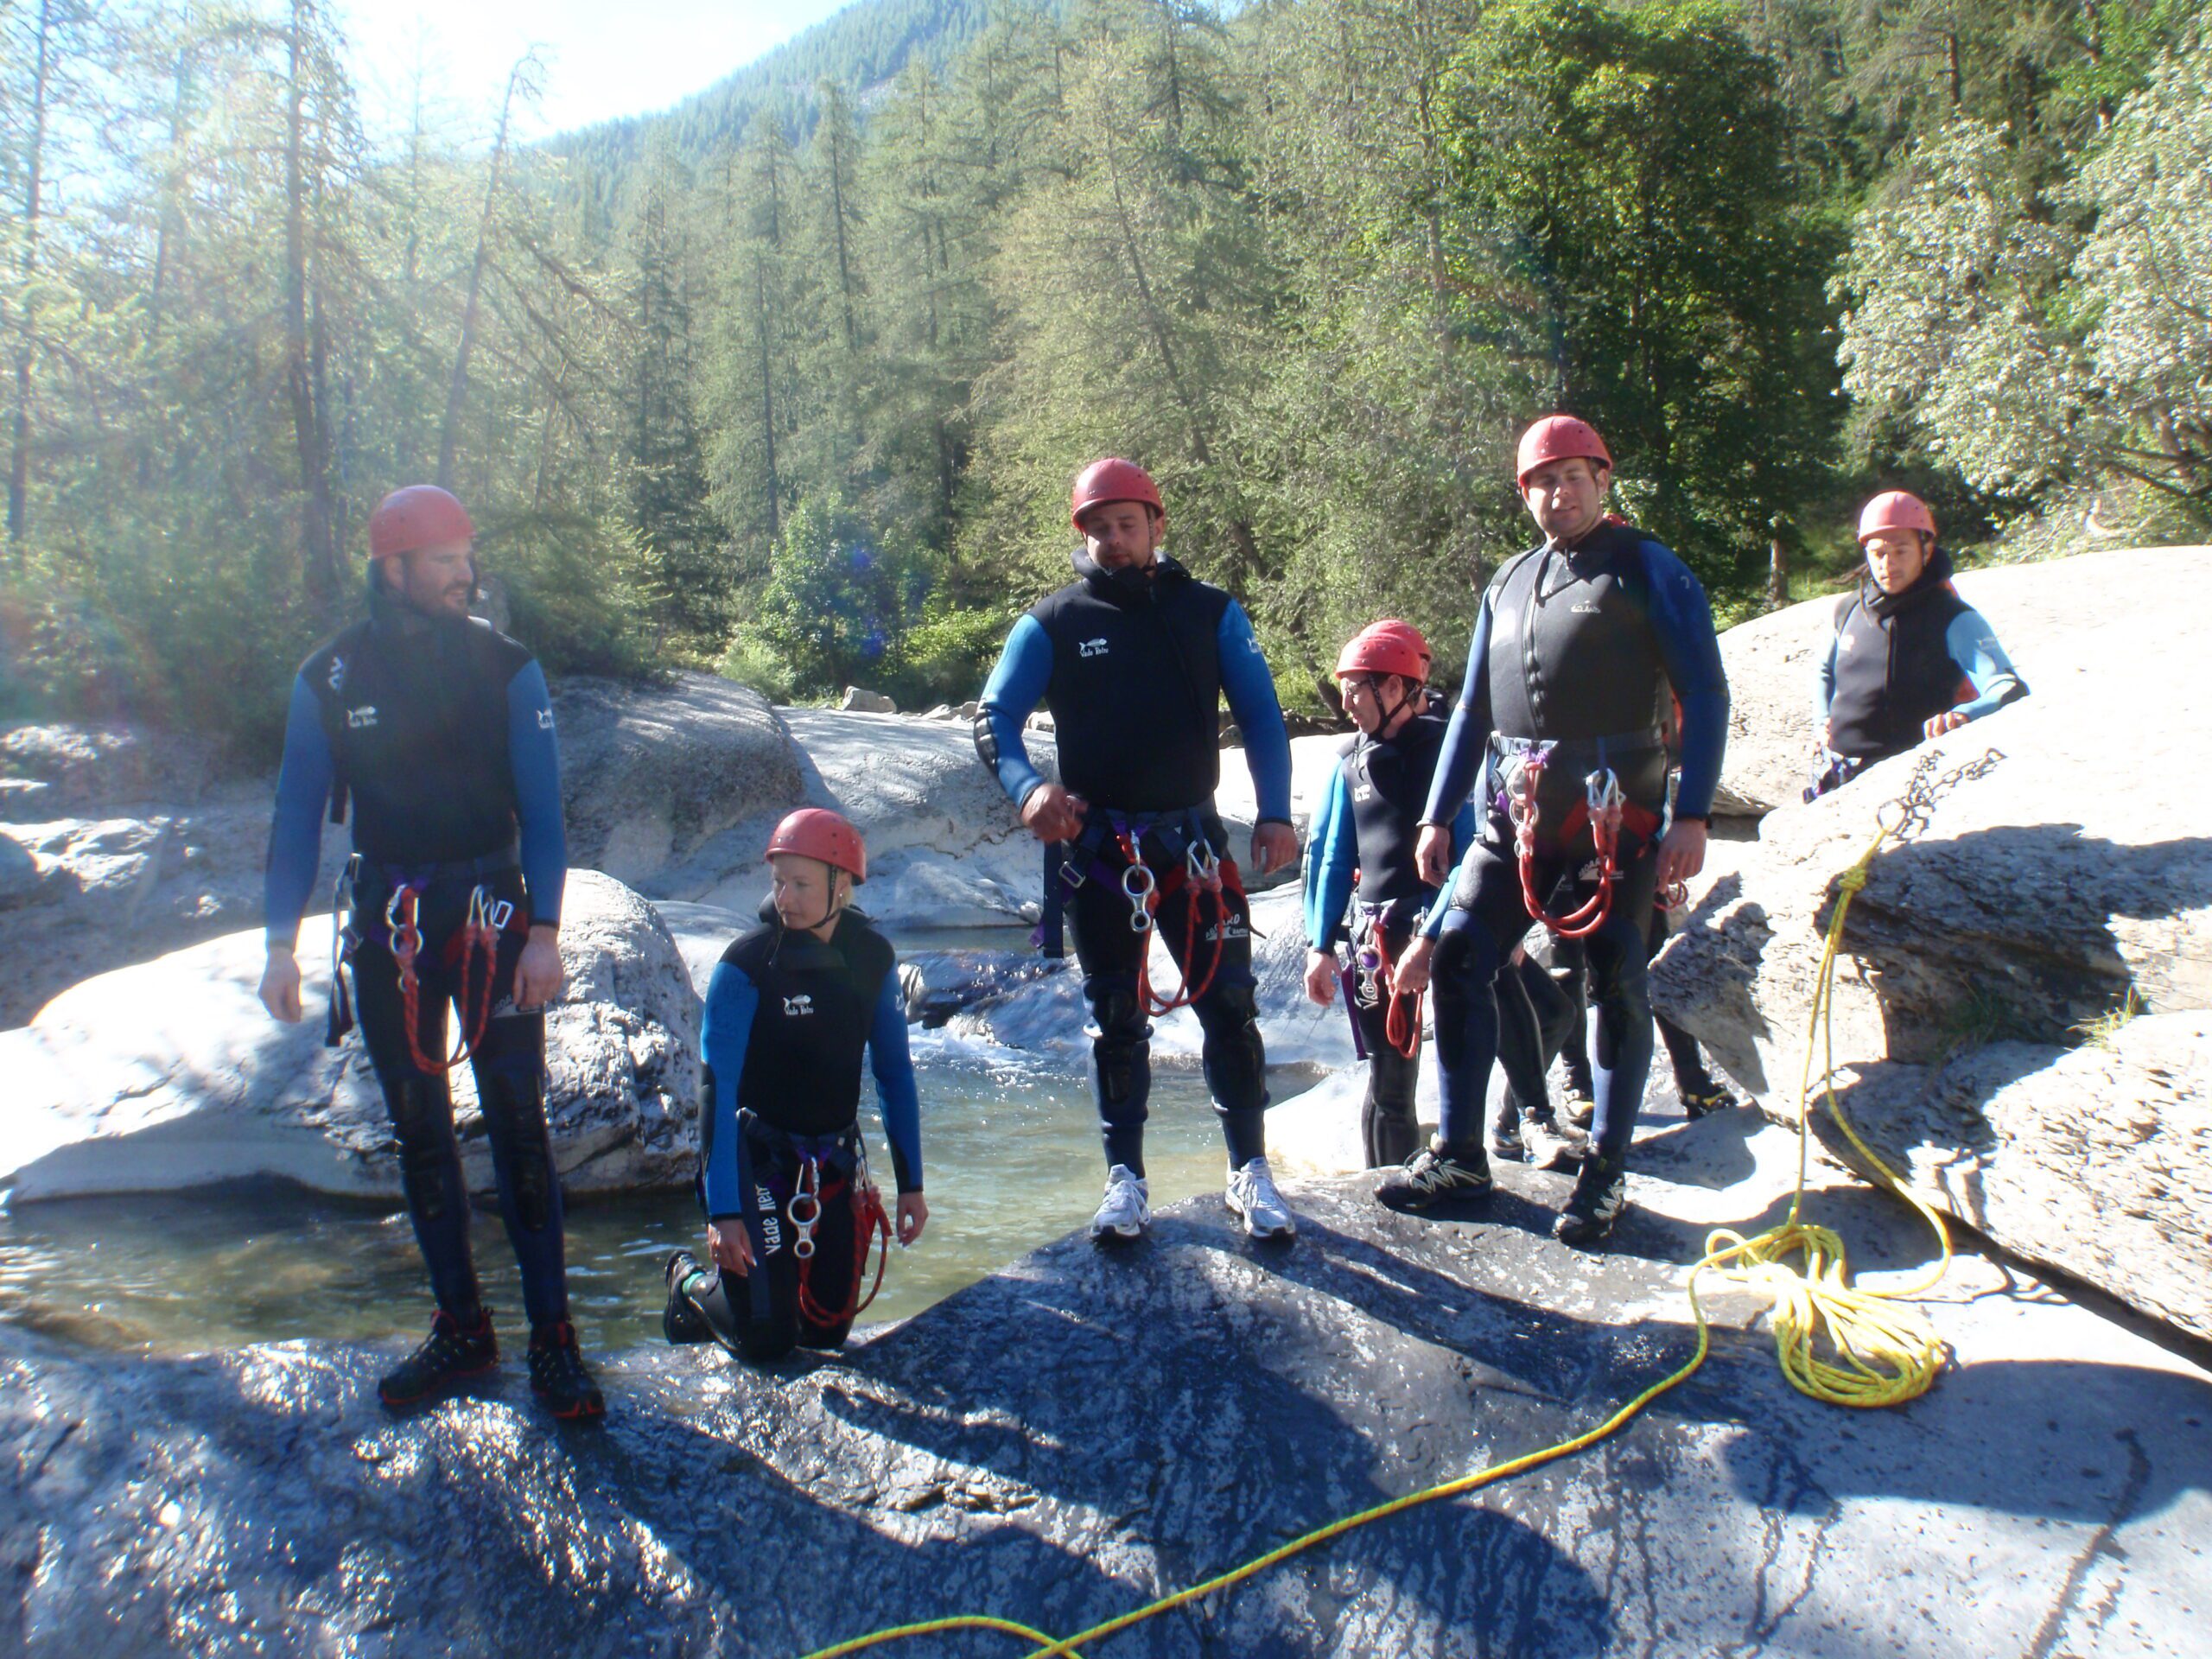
[265,586,569,1330]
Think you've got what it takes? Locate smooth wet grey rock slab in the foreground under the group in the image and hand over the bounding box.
[0,1173,2212,1659]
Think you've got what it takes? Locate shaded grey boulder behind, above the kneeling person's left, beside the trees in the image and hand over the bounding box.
[553,672,805,885]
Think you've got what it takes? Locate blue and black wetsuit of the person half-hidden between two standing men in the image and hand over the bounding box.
[1305,715,1476,1168]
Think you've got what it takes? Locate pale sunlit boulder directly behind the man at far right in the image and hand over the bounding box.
[1714,546,2212,818]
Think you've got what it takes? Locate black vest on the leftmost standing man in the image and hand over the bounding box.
[301,615,531,865]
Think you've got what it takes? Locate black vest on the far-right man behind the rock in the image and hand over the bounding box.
[1827,549,1974,761]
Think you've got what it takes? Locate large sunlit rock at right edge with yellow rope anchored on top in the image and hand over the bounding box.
[1652,549,2212,1332]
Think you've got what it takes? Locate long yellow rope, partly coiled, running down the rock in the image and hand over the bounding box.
[807,750,2004,1659]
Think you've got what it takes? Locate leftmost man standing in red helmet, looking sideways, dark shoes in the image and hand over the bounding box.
[261,485,606,1418]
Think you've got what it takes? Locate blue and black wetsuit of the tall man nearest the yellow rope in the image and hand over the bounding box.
[1422,520,1727,1159]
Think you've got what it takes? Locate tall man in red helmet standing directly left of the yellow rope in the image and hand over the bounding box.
[1378,416,1727,1245]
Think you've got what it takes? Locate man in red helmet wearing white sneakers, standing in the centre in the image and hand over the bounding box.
[976,460,1299,1241]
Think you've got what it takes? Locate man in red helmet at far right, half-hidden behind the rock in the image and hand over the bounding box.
[1805,489,2029,801]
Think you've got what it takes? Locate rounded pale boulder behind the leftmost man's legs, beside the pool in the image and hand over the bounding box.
[0,869,699,1204]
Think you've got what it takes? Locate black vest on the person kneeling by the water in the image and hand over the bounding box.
[721,925,898,1135]
